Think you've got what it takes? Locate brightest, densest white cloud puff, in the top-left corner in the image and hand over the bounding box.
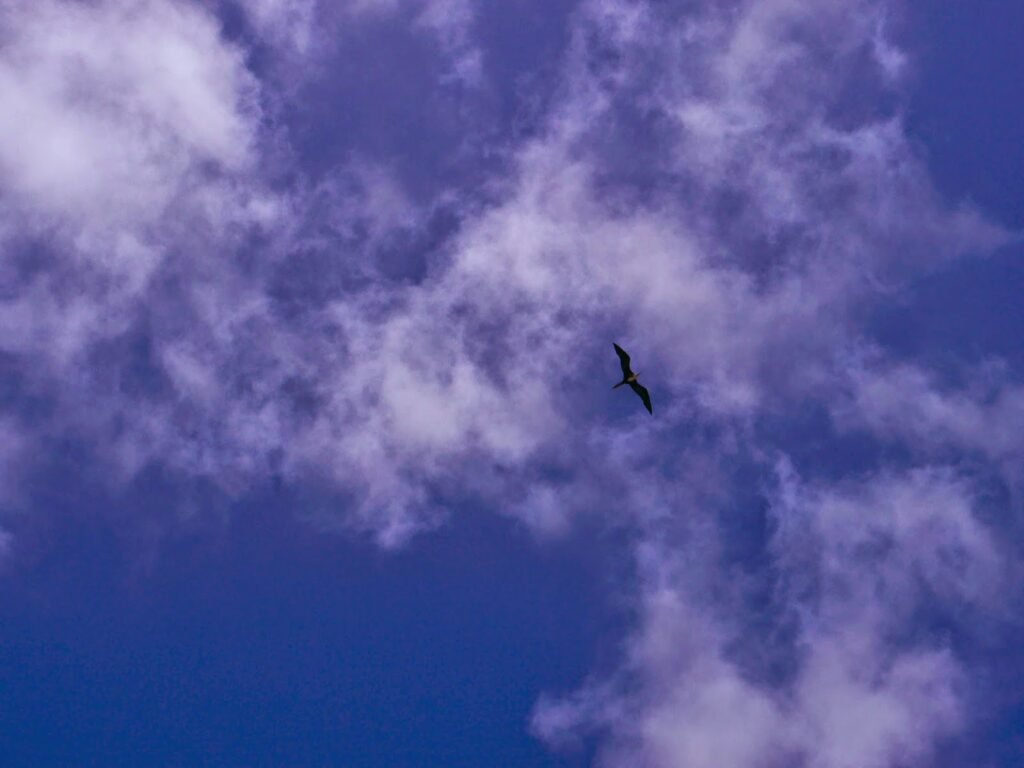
[0,0,257,226]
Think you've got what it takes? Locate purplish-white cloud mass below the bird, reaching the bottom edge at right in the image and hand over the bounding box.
[532,463,1005,768]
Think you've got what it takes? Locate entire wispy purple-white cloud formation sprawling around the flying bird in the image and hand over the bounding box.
[0,0,1024,768]
